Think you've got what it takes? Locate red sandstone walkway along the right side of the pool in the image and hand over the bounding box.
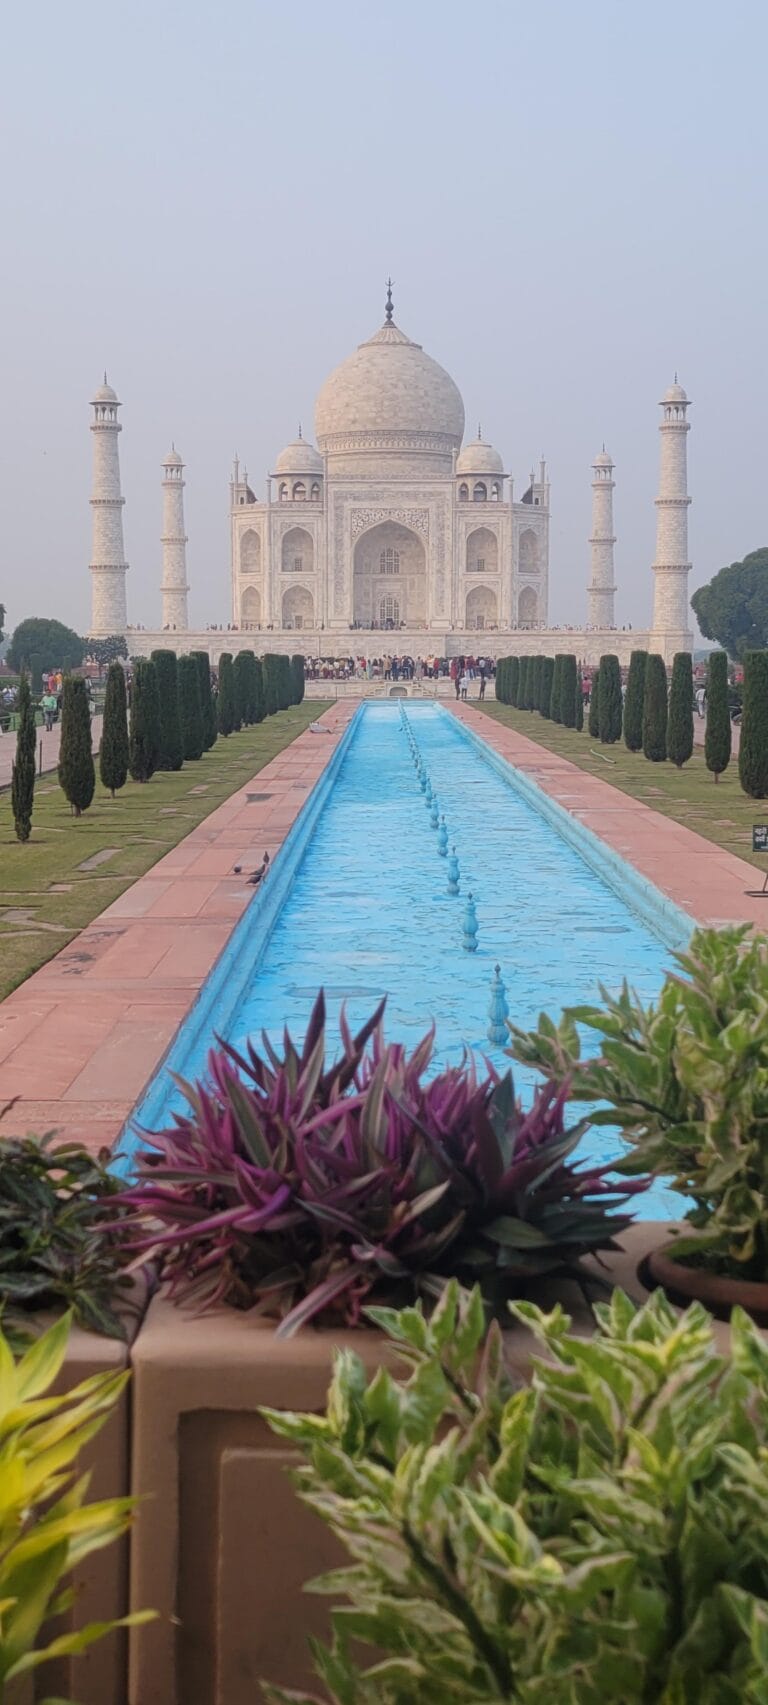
[447,702,768,929]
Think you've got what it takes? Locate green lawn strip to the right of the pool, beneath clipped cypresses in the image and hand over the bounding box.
[476,699,768,873]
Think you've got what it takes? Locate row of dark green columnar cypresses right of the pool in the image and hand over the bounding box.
[497,650,768,800]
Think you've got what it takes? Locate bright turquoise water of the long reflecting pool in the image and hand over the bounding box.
[127,702,689,1217]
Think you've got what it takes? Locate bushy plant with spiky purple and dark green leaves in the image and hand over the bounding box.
[114,991,649,1337]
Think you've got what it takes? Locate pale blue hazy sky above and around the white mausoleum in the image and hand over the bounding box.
[0,0,768,641]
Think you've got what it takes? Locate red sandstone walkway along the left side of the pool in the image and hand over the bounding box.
[0,701,357,1149]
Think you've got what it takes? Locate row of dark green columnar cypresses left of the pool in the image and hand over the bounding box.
[10,650,304,841]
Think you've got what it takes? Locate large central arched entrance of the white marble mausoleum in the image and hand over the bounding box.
[352,522,427,627]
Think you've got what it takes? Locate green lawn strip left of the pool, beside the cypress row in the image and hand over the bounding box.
[0,699,328,999]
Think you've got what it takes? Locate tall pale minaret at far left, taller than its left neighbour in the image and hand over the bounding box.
[90,373,128,634]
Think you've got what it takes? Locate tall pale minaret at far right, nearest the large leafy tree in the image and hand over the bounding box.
[650,383,693,662]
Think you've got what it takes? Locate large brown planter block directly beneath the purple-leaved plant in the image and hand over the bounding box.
[128,1226,660,1705]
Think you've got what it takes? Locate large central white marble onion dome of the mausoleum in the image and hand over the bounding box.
[314,321,464,454]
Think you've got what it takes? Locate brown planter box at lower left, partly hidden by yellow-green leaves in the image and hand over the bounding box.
[9,1279,148,1705]
